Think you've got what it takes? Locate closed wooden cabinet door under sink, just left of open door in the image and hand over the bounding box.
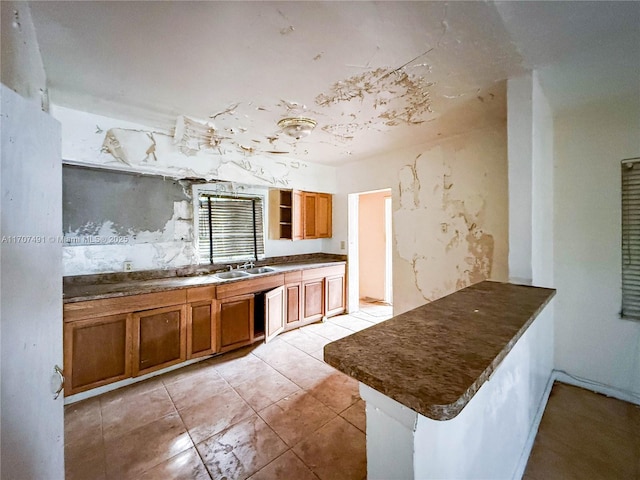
[217,294,254,352]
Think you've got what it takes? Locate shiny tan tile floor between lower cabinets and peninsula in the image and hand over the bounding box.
[65,304,391,480]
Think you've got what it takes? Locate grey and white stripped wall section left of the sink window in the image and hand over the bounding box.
[62,165,197,275]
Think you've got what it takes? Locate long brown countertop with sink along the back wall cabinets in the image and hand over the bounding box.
[63,259,346,303]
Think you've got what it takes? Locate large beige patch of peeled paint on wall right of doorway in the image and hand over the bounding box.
[394,139,501,301]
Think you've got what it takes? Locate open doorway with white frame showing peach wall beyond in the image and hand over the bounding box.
[347,189,393,313]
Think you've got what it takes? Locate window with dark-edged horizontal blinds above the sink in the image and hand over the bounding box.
[198,193,264,263]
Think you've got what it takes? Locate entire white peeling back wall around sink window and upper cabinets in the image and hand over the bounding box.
[52,106,336,275]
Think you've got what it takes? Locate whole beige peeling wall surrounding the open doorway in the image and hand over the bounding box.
[334,123,508,313]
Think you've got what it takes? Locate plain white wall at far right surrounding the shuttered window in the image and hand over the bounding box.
[554,95,640,395]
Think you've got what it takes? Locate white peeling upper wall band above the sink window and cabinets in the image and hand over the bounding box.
[51,105,336,193]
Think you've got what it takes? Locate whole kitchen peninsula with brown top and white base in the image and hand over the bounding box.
[324,281,555,479]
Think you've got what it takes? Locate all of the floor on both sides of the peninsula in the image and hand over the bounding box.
[65,304,640,480]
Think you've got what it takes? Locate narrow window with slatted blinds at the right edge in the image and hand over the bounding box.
[621,158,640,320]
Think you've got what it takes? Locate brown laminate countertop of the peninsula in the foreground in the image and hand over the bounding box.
[324,281,555,420]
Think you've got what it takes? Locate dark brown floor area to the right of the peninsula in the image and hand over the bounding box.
[523,382,640,480]
